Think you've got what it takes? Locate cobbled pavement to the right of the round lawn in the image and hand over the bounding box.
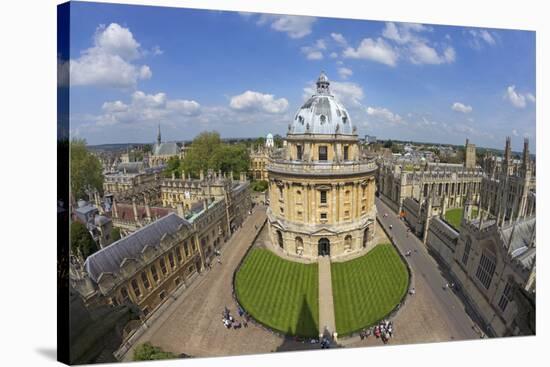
[340,199,486,347]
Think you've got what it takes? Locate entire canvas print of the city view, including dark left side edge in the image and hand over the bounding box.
[57,2,537,364]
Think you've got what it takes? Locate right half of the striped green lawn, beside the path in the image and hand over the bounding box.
[331,244,409,335]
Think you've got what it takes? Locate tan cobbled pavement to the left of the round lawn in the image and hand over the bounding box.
[124,207,319,361]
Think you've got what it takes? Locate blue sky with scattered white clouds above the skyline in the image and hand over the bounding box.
[67,2,536,151]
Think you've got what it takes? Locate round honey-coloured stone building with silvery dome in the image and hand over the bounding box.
[267,73,376,259]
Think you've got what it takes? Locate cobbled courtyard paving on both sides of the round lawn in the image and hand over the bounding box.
[119,201,479,361]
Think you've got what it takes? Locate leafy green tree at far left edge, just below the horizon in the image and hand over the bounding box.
[70,139,103,200]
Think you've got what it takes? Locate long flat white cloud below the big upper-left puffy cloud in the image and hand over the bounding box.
[96,91,201,126]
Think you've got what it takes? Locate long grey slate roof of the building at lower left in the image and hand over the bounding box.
[84,213,191,282]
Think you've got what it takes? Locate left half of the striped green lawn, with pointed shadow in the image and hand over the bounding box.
[235,248,319,337]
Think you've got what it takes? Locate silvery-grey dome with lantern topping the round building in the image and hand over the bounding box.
[288,72,355,135]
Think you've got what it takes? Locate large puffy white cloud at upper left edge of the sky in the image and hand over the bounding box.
[70,23,152,88]
